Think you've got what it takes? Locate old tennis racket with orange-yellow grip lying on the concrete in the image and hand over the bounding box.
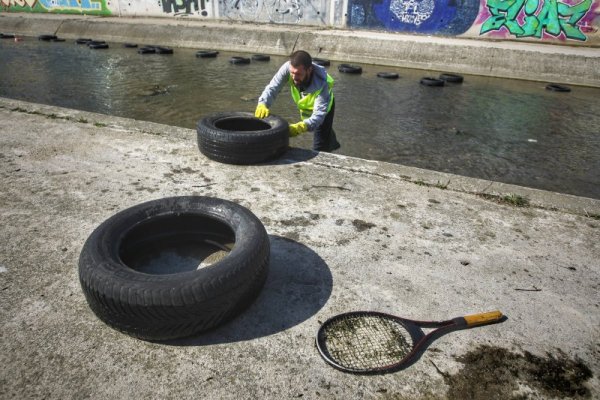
[316,311,504,374]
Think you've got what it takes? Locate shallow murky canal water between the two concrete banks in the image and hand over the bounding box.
[0,37,600,199]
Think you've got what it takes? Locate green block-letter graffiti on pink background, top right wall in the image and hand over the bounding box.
[480,0,593,40]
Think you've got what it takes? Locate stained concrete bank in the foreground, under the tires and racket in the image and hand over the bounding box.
[0,98,600,399]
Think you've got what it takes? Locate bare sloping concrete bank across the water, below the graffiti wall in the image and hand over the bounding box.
[0,13,600,87]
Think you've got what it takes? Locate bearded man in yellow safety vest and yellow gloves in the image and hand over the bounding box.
[254,50,340,151]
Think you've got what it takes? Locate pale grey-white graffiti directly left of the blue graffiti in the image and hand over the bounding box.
[219,0,328,25]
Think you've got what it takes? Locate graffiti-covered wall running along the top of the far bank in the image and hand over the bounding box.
[0,0,600,46]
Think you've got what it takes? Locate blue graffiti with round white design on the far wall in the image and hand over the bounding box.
[348,0,479,35]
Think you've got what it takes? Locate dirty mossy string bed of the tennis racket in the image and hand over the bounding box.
[322,315,413,370]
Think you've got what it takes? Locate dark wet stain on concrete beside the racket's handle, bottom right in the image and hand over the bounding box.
[440,346,592,400]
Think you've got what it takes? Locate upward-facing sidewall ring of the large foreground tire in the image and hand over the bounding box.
[79,196,268,298]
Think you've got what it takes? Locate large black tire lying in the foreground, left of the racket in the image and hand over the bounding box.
[79,196,270,340]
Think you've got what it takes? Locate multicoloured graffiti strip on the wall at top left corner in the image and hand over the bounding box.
[0,0,110,15]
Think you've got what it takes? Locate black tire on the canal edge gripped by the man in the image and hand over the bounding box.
[197,112,290,165]
